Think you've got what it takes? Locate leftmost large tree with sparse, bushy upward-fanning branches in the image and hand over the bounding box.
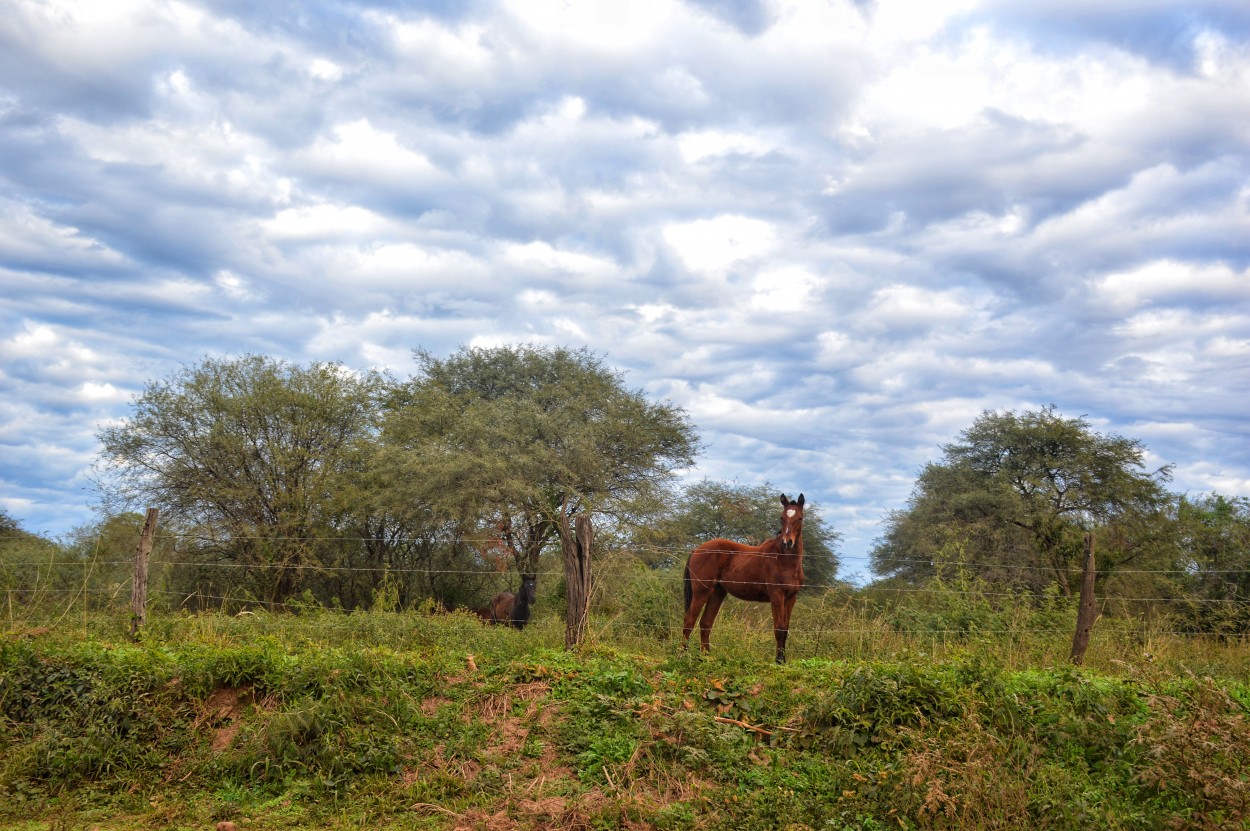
[99,355,383,601]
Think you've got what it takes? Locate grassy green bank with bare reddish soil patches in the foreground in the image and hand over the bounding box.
[0,611,1250,831]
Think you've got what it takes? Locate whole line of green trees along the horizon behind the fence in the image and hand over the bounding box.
[0,346,1250,632]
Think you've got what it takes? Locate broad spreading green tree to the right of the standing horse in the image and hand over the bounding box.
[871,406,1170,595]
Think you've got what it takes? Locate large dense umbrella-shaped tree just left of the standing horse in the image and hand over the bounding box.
[379,346,698,574]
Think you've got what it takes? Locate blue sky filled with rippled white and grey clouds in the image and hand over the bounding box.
[0,0,1250,579]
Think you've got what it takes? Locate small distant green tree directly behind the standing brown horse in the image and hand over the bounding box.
[638,479,840,591]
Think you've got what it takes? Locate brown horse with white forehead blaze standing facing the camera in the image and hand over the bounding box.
[681,494,804,664]
